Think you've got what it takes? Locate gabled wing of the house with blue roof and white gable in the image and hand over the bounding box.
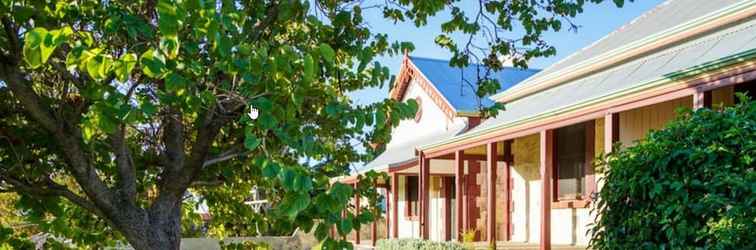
[341,55,538,243]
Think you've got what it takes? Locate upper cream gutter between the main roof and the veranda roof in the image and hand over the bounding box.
[491,1,756,102]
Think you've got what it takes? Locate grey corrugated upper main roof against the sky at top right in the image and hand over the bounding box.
[504,0,743,93]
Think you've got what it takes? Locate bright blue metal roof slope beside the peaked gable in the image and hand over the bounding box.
[410,56,540,112]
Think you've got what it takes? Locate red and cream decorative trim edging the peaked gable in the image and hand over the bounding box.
[389,54,457,120]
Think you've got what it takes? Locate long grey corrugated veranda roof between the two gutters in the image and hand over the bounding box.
[465,15,756,134]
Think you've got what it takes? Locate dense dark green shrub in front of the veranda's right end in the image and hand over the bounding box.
[590,95,756,249]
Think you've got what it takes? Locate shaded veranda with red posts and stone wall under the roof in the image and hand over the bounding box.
[351,80,756,249]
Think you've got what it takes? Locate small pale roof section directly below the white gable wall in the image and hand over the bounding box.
[356,122,465,173]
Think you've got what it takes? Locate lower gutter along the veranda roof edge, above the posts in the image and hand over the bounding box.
[417,49,756,153]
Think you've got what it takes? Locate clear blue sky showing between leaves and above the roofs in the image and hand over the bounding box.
[350,0,662,104]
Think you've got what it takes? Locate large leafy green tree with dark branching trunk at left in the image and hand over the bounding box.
[0,0,621,249]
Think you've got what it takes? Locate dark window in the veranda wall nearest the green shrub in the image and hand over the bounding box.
[554,122,594,201]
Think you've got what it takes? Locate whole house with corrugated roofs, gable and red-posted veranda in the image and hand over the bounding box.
[342,0,756,249]
